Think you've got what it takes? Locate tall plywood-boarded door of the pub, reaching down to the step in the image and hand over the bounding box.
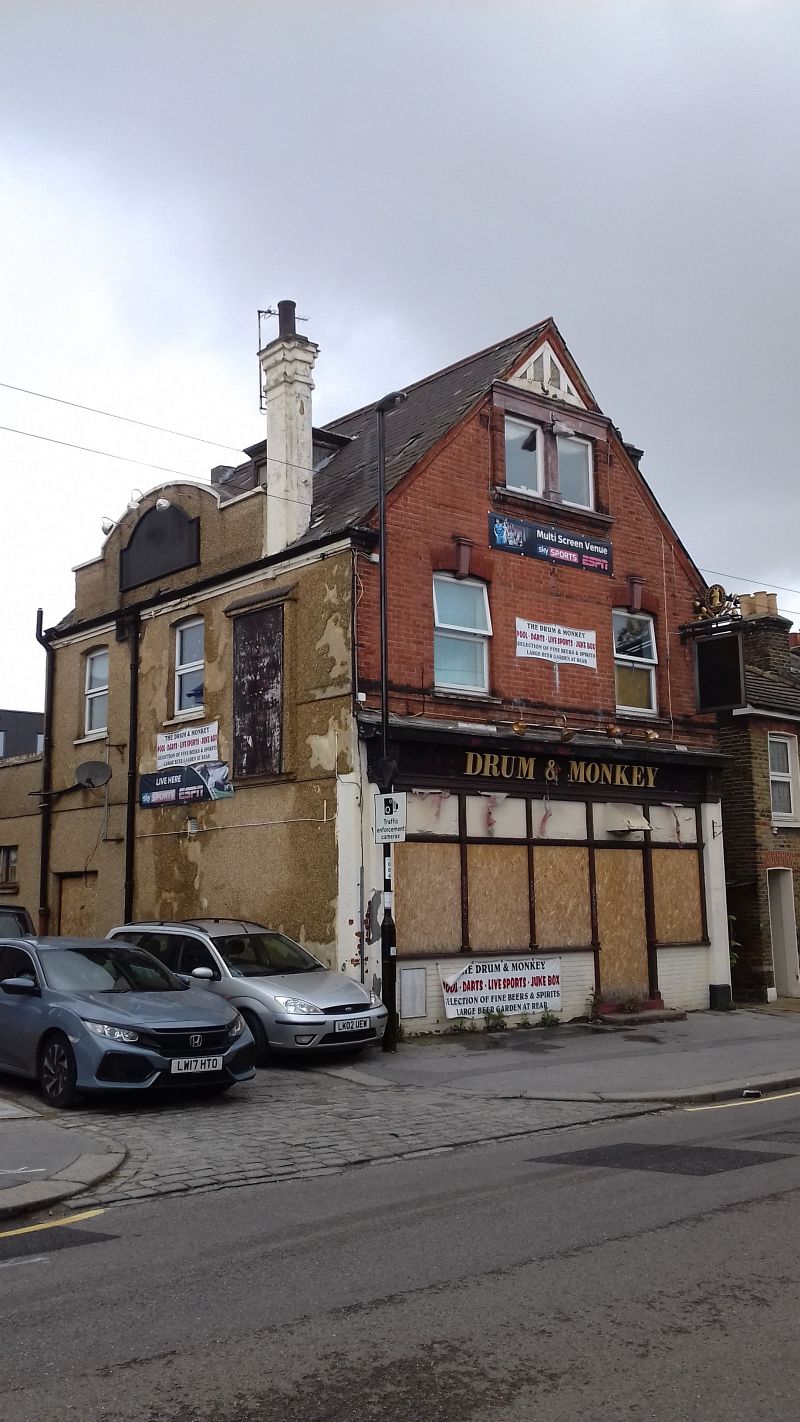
[595,849,648,997]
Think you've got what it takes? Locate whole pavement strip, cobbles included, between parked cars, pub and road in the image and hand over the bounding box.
[0,1005,800,1219]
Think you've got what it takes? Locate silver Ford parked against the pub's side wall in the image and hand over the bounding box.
[108,919,388,1065]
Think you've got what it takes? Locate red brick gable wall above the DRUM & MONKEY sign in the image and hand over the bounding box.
[357,398,715,744]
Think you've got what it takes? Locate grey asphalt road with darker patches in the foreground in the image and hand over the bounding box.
[0,1095,800,1422]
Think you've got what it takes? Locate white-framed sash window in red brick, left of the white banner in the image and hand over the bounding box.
[433,573,492,691]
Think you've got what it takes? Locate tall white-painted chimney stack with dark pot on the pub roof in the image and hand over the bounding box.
[259,301,320,555]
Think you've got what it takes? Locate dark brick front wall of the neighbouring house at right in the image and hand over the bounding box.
[719,717,800,998]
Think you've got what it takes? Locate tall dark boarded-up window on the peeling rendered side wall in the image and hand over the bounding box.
[233,603,283,779]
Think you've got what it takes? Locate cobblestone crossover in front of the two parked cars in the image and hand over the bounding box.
[58,1067,647,1209]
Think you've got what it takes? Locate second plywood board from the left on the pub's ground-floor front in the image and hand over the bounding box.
[466,845,530,953]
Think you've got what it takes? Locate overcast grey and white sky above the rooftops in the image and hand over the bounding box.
[0,0,800,710]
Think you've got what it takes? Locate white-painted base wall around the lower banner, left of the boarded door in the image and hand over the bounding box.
[398,948,593,1035]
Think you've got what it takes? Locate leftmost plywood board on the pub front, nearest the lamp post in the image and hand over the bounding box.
[394,842,462,956]
